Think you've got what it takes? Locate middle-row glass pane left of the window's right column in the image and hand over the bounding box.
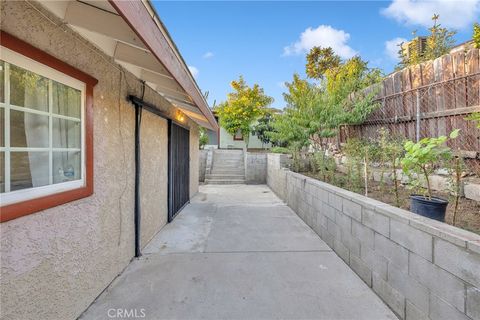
[10,110,49,148]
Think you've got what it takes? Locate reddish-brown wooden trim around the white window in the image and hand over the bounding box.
[0,30,98,222]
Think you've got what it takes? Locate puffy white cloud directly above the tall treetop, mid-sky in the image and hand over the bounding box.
[283,25,357,58]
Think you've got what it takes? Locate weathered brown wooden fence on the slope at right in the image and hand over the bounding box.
[339,49,480,169]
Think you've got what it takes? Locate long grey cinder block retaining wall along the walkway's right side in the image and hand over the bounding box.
[267,154,480,320]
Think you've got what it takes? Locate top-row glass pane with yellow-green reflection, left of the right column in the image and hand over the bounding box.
[10,64,48,111]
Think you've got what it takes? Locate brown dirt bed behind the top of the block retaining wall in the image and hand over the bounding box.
[302,172,480,234]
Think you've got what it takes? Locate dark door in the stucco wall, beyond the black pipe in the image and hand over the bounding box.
[168,121,190,222]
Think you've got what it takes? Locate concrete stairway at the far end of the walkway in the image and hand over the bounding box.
[205,149,245,184]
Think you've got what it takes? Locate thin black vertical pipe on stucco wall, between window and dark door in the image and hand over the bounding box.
[134,104,142,258]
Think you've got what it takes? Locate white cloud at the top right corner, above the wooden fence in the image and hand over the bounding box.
[382,0,480,29]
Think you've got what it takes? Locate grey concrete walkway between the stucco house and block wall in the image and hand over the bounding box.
[81,185,397,320]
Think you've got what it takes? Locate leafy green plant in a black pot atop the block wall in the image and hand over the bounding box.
[401,129,460,221]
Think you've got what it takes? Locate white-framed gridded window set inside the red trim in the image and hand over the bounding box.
[0,47,85,206]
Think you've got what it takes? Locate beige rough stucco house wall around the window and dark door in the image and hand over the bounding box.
[0,1,198,319]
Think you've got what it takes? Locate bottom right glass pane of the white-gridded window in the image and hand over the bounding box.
[53,151,82,183]
